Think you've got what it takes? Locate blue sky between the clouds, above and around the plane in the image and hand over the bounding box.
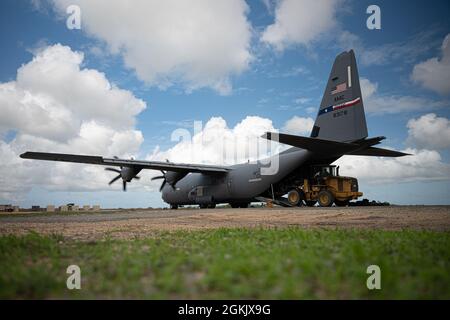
[0,0,450,207]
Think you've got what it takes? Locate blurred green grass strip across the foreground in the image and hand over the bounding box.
[0,228,450,299]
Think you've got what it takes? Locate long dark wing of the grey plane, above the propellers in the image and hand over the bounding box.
[20,152,230,174]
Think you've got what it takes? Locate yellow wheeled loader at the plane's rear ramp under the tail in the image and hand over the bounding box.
[287,165,363,207]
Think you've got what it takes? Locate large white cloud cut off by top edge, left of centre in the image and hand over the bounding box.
[52,0,252,94]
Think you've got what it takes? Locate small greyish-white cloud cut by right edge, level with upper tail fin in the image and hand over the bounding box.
[411,34,450,95]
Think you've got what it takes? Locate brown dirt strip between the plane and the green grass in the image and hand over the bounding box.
[0,206,450,240]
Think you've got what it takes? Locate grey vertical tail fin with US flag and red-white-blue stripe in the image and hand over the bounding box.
[311,50,368,142]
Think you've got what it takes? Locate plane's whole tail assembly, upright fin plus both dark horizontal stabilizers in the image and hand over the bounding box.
[263,50,408,158]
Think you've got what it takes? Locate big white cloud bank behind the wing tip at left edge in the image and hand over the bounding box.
[0,44,146,200]
